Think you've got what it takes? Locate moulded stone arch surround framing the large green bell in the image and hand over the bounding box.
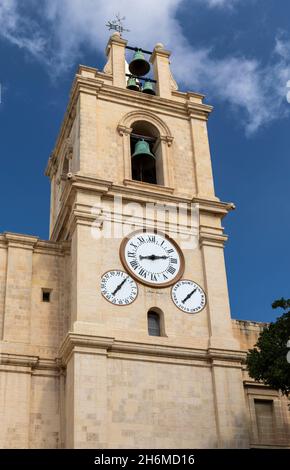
[118,110,174,187]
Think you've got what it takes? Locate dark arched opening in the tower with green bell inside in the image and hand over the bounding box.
[130,121,164,184]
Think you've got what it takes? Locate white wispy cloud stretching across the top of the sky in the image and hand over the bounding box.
[0,0,290,134]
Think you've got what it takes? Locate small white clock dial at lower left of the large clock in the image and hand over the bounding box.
[101,271,138,305]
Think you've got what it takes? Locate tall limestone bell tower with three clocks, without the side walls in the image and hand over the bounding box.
[47,33,248,449]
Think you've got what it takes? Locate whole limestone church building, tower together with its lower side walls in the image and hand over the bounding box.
[0,33,289,449]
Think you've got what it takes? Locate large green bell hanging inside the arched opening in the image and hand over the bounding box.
[132,139,156,182]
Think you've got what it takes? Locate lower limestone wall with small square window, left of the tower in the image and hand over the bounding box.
[0,233,68,448]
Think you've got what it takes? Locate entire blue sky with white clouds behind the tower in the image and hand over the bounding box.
[0,0,290,321]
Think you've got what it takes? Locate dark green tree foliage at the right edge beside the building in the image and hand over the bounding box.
[247,298,290,396]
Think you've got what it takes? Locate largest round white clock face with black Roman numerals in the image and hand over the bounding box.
[120,231,184,287]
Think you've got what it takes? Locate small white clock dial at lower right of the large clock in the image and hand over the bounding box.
[171,279,206,313]
